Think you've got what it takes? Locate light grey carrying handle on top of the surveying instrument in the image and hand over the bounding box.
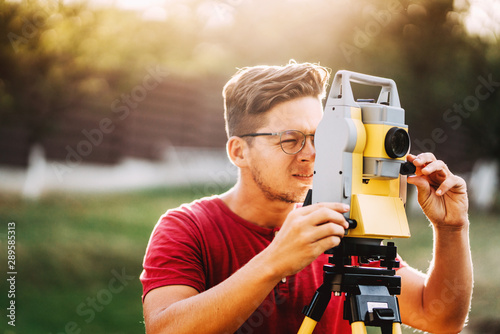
[329,70,401,108]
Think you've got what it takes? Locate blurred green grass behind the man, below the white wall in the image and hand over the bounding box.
[0,187,500,334]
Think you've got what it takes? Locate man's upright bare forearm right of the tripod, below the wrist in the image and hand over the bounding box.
[422,222,473,332]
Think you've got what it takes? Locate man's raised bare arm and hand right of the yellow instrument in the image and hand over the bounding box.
[398,153,473,333]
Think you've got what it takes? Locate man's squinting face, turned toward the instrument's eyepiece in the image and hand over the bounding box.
[244,97,323,203]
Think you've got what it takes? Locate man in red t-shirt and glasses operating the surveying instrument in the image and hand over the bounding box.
[141,63,472,333]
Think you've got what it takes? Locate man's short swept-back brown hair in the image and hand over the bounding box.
[222,60,330,137]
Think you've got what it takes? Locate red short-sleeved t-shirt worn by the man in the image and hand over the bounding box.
[140,196,402,334]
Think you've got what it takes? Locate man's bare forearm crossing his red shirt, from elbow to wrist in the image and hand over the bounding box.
[147,252,281,333]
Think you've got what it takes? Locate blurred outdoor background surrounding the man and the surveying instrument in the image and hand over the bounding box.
[0,0,500,334]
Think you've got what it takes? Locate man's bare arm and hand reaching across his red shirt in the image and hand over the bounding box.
[144,203,348,334]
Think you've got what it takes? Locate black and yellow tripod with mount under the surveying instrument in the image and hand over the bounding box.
[298,238,401,334]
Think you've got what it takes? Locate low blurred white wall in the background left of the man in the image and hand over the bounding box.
[0,146,237,198]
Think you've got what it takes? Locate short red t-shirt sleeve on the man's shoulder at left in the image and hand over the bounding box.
[140,210,205,300]
